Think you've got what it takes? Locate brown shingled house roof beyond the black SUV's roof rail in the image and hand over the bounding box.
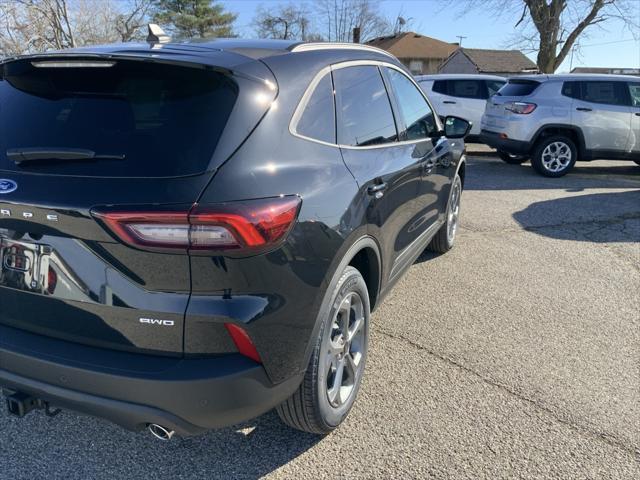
[367,32,458,59]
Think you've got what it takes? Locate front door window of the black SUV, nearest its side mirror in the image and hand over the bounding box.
[385,68,437,140]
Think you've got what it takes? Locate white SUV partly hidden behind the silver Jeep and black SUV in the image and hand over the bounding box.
[416,75,507,142]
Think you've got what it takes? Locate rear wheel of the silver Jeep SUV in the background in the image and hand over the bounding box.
[531,135,578,178]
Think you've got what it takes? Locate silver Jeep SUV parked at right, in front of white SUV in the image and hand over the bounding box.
[480,75,640,177]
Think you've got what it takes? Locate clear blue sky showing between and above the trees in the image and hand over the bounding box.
[222,0,640,72]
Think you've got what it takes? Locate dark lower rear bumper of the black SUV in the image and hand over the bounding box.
[0,327,302,436]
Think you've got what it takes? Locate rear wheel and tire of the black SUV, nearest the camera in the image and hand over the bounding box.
[276,266,371,435]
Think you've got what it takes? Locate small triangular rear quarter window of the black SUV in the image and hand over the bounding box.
[295,73,336,143]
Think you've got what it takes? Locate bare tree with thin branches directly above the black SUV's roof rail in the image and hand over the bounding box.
[316,0,393,42]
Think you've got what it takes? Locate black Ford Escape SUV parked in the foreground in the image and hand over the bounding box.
[0,34,469,439]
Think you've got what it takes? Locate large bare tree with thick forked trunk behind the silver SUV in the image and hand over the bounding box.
[447,0,640,73]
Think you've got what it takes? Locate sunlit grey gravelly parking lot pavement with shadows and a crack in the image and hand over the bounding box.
[0,157,640,480]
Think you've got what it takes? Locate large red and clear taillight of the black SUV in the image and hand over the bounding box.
[93,196,300,253]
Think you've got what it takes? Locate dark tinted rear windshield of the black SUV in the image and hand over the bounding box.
[0,60,238,177]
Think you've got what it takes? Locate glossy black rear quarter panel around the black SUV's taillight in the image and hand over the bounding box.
[185,52,376,382]
